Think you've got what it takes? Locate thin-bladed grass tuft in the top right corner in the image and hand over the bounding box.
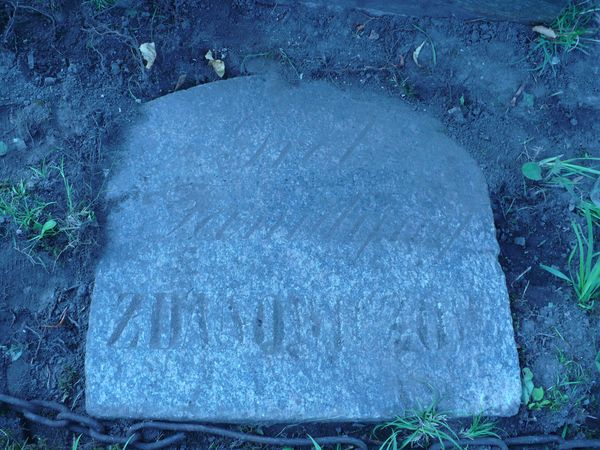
[533,1,600,73]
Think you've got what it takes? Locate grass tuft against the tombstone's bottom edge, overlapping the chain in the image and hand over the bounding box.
[374,405,461,450]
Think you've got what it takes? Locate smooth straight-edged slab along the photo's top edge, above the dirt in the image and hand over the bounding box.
[298,0,569,24]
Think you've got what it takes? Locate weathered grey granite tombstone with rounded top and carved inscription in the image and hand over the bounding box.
[86,77,521,422]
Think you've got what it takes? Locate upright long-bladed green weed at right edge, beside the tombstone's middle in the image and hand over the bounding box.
[541,210,600,310]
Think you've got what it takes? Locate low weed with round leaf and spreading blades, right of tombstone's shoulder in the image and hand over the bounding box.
[521,155,600,192]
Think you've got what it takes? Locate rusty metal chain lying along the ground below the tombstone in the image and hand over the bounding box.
[0,394,600,450]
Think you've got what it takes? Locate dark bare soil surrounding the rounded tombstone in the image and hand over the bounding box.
[0,0,600,448]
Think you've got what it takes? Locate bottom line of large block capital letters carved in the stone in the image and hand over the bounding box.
[107,290,465,361]
